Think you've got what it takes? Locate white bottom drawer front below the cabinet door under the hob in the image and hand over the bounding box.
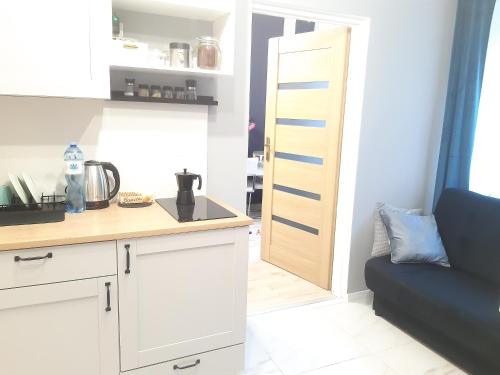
[121,344,245,375]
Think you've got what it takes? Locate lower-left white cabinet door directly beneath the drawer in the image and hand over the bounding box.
[0,276,119,375]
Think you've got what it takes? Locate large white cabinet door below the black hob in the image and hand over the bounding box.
[118,227,248,371]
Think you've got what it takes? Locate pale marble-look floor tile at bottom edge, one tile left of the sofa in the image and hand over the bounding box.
[304,356,399,375]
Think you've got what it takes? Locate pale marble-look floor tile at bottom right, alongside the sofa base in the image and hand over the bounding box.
[379,341,466,375]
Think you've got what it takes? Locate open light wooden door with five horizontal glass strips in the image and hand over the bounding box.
[261,28,350,289]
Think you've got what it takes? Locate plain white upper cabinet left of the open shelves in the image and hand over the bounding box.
[0,0,111,98]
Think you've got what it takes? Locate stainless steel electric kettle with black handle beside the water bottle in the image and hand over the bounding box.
[85,160,120,210]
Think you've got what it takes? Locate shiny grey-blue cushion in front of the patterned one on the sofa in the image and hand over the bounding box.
[380,208,450,267]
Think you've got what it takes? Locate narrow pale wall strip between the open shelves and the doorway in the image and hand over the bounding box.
[207,0,251,211]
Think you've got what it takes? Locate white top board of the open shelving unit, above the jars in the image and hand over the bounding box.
[113,0,233,21]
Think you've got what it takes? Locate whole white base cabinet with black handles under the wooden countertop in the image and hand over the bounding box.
[0,227,248,375]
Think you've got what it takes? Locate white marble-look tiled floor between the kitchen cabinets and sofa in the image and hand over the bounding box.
[245,301,465,375]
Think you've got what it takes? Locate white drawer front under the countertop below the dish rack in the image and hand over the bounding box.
[0,241,116,289]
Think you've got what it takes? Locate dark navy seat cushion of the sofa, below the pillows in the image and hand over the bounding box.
[365,256,500,361]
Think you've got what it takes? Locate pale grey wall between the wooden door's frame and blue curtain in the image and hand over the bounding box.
[265,0,456,292]
